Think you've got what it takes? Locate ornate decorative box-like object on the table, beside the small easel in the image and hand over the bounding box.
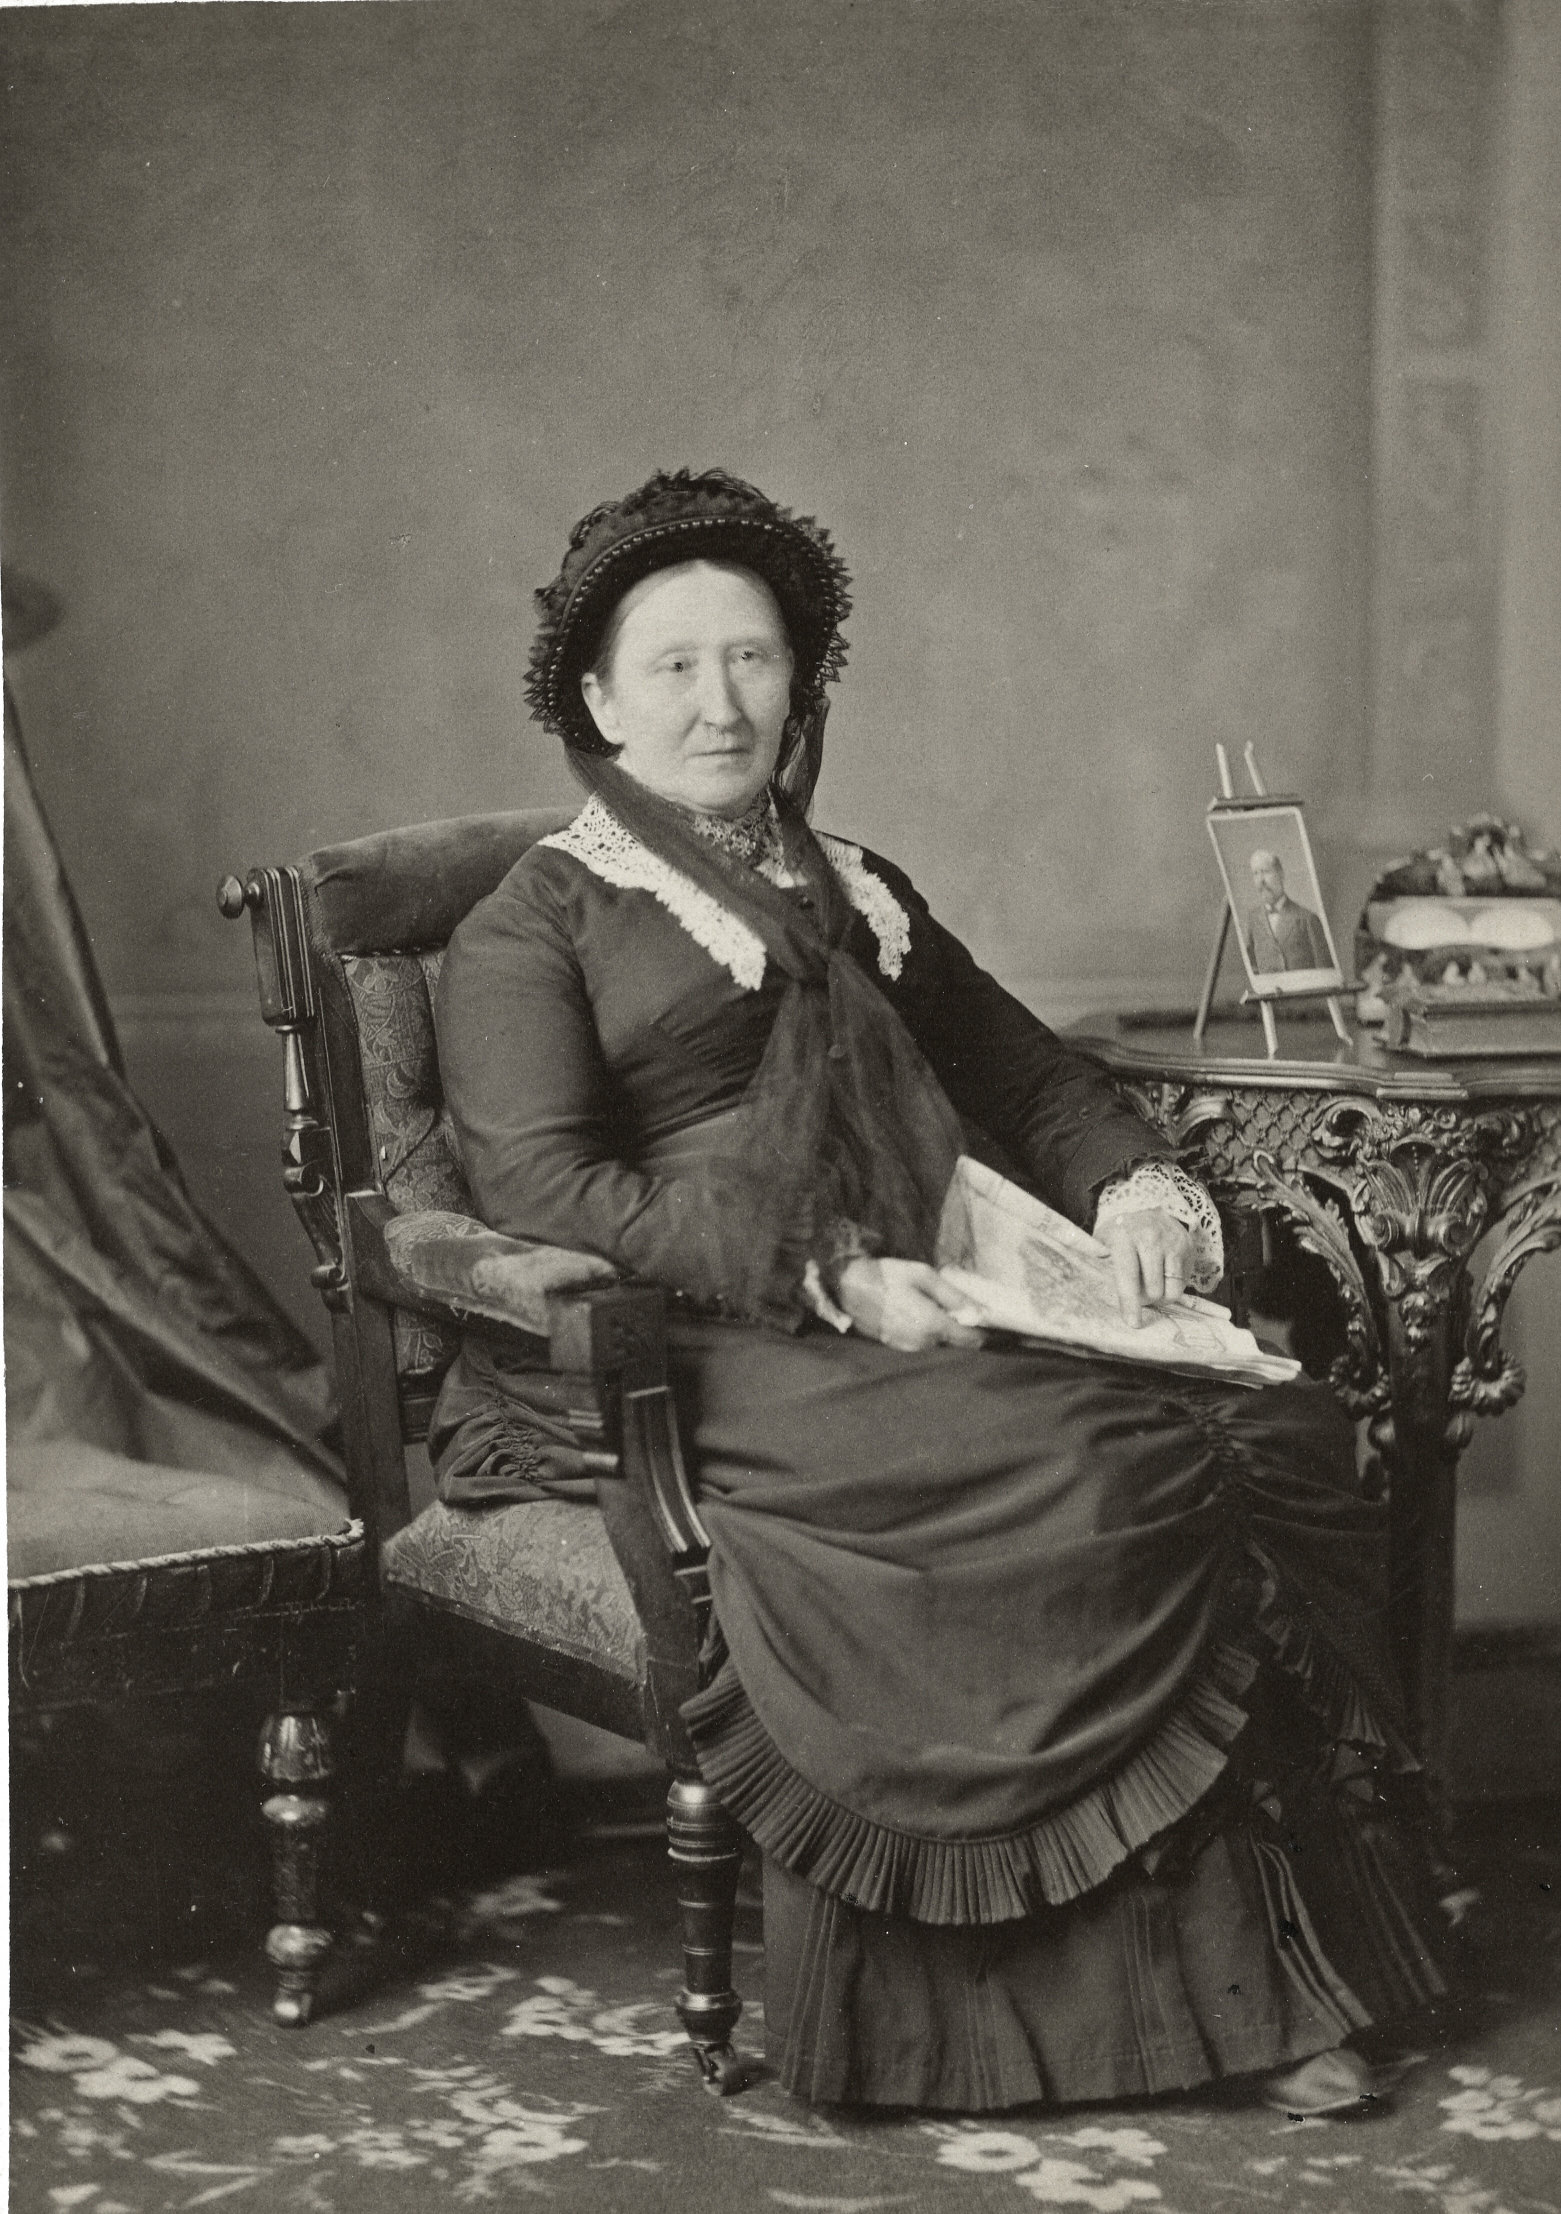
[1355,815,1561,1052]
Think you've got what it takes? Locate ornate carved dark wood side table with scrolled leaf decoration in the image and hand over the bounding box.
[1069,1016,1561,1780]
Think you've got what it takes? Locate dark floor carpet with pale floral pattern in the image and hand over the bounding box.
[11,1726,1561,2214]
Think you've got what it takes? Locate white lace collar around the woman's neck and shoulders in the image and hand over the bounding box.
[538,793,910,992]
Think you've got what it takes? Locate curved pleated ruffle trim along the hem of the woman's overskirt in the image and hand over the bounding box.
[682,1645,1258,1926]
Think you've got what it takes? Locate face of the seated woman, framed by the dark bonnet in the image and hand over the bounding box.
[580,560,790,815]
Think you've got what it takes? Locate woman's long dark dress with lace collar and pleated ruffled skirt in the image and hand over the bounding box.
[432,801,1441,2110]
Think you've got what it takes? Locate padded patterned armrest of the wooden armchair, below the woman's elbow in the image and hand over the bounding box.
[348,1191,618,1337]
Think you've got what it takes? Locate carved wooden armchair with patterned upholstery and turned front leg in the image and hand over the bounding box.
[219,810,742,2092]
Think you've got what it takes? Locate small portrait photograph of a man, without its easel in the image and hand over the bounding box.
[1207,799,1344,999]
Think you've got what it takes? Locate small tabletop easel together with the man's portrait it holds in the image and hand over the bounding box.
[1193,744,1351,1061]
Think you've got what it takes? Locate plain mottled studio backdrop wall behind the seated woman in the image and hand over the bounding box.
[0,0,1561,1664]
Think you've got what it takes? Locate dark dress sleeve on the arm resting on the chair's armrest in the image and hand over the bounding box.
[434,879,731,1304]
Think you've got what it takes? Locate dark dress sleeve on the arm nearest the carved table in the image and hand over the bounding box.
[864,855,1171,1229]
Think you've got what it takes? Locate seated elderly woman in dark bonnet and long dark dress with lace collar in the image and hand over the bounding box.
[432,472,1439,2112]
